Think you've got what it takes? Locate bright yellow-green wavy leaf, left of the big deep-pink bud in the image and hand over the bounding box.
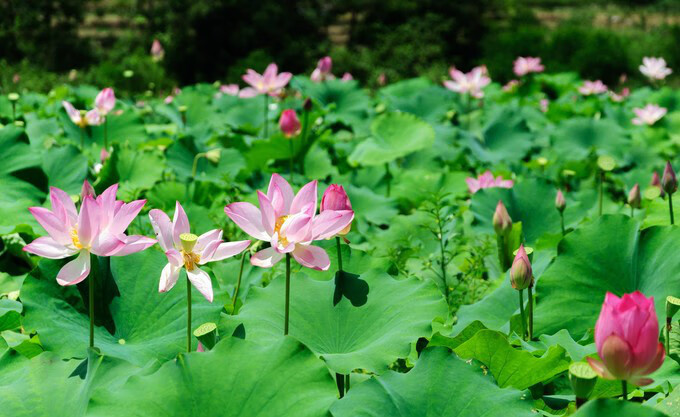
[454,330,571,389]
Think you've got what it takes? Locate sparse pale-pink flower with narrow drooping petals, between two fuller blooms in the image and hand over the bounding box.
[149,202,250,303]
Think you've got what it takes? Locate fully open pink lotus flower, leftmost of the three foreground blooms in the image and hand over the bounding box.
[24,181,156,285]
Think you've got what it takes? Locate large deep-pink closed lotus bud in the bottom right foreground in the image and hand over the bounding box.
[588,291,666,385]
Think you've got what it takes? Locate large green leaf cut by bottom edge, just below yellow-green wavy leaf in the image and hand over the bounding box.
[331,347,534,417]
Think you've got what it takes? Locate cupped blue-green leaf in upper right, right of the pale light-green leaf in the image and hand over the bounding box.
[466,109,533,163]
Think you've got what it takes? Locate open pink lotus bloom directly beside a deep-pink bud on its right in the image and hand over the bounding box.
[224,174,354,271]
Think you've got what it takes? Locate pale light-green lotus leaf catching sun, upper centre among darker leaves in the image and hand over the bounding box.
[348,113,435,166]
